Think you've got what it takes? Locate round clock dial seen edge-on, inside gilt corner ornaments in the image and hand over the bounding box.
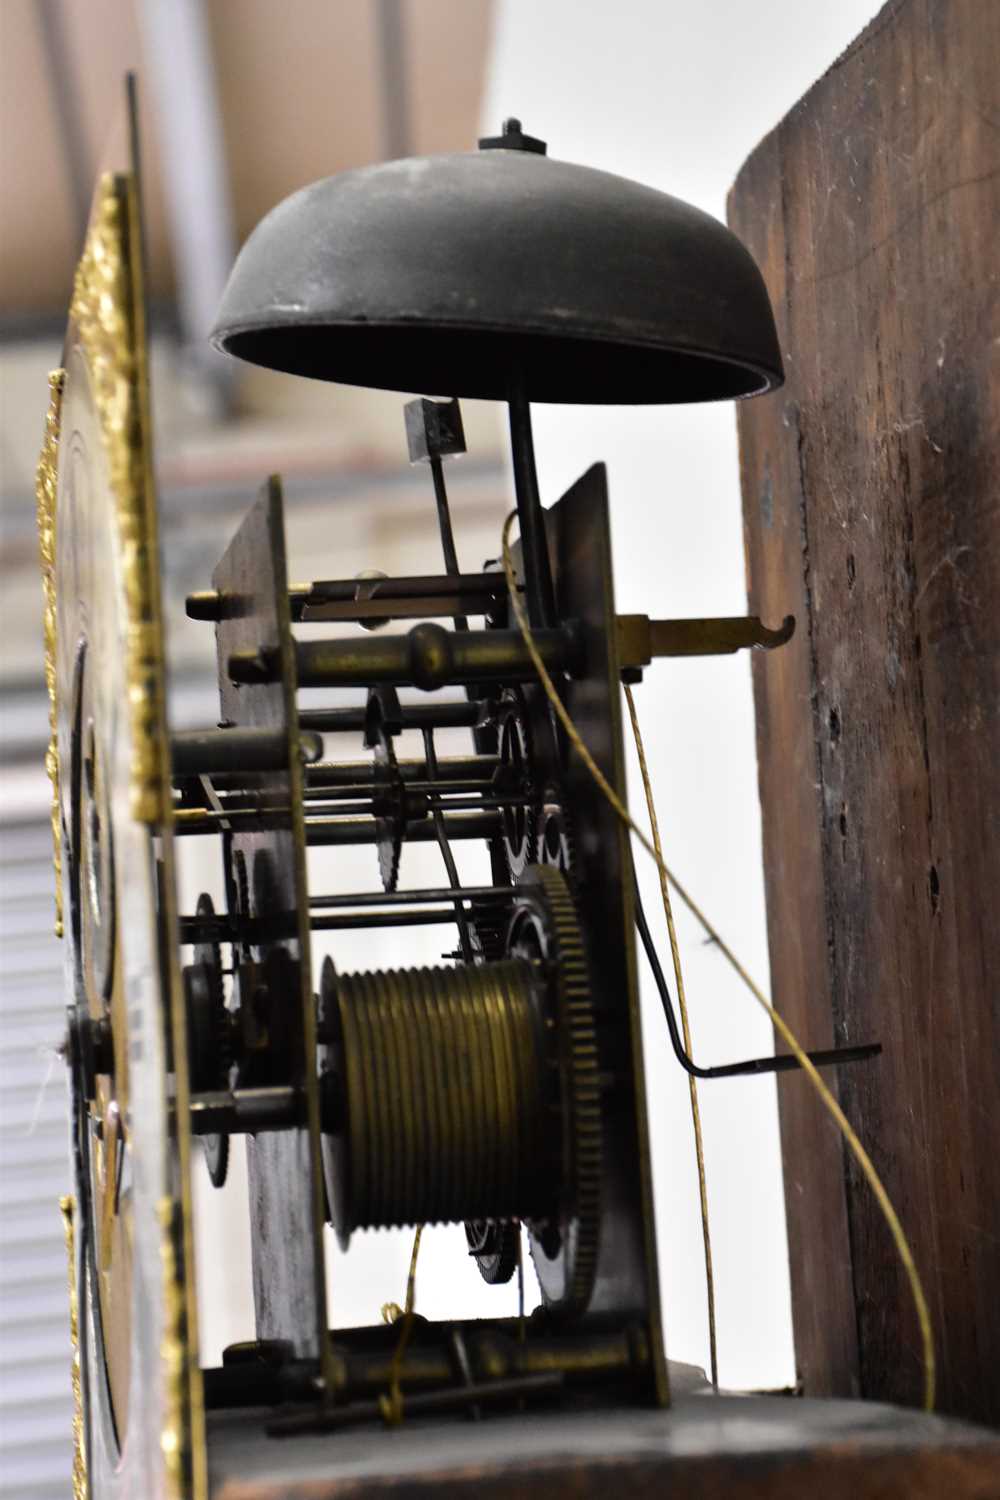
[55,348,133,1445]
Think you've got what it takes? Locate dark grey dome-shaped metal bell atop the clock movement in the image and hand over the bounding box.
[213,120,783,404]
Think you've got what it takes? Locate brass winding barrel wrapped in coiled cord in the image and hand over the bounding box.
[319,959,562,1244]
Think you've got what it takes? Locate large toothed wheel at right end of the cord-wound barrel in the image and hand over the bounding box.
[507,864,601,1317]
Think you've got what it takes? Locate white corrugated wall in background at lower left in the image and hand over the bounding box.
[0,816,72,1500]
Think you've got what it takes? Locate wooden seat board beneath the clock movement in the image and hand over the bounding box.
[208,1386,1000,1500]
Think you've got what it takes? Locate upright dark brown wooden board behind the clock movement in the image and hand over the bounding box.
[729,0,1000,1422]
